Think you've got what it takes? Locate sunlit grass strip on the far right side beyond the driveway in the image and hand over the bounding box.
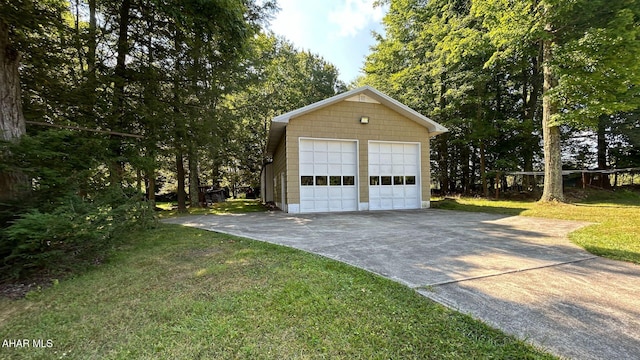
[432,190,640,264]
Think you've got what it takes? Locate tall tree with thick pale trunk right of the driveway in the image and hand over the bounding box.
[473,0,640,201]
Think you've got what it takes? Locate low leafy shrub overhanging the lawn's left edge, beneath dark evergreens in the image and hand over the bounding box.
[0,191,154,281]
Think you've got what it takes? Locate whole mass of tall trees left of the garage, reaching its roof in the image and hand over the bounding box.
[0,0,344,275]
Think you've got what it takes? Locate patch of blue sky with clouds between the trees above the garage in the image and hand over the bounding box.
[271,0,386,83]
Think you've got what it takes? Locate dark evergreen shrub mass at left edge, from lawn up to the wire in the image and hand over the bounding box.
[0,130,155,280]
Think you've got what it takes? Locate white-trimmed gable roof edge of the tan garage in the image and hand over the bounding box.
[267,85,449,154]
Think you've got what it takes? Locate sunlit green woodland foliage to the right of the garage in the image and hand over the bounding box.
[360,0,640,193]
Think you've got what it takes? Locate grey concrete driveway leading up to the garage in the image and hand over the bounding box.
[166,209,640,359]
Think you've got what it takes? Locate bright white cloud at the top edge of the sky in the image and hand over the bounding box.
[328,0,385,37]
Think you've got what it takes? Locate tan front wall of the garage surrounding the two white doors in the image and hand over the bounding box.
[285,101,431,211]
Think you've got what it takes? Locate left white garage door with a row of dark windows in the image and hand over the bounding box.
[300,139,358,212]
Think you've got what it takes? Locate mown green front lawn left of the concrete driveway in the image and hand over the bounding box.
[0,225,552,359]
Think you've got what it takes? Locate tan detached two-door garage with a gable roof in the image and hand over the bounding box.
[262,86,447,213]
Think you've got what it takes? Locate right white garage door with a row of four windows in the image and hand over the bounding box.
[369,141,421,210]
